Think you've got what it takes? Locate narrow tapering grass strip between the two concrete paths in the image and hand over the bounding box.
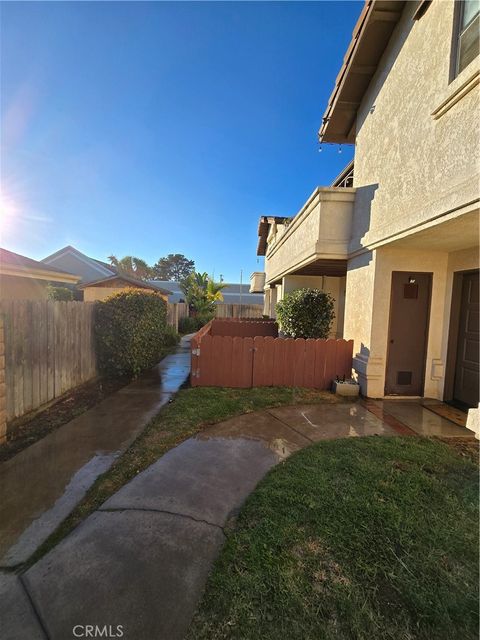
[25,387,341,566]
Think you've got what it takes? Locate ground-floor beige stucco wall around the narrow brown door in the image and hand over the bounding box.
[344,247,478,399]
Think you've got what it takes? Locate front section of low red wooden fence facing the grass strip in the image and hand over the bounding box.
[191,321,353,389]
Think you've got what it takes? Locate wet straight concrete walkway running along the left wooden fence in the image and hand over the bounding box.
[0,337,190,567]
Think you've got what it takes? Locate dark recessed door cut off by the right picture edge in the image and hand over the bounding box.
[453,272,479,407]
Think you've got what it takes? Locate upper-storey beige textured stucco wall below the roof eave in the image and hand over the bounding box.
[350,0,480,251]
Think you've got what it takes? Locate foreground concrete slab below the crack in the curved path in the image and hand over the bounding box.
[23,511,224,640]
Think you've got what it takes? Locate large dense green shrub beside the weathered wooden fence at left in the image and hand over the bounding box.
[95,289,167,376]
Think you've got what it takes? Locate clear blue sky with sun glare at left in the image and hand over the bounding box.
[0,2,362,282]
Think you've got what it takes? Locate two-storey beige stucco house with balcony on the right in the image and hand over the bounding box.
[258,0,480,419]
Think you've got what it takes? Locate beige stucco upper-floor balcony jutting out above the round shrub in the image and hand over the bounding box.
[257,187,355,284]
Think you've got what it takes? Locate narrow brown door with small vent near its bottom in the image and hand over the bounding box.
[385,271,432,396]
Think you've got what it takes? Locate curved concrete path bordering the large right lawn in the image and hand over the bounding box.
[12,403,396,640]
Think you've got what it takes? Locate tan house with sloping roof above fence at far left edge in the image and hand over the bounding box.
[0,249,80,300]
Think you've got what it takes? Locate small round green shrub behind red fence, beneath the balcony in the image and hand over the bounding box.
[275,289,335,338]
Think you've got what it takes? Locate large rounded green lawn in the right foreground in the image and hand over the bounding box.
[188,436,478,640]
